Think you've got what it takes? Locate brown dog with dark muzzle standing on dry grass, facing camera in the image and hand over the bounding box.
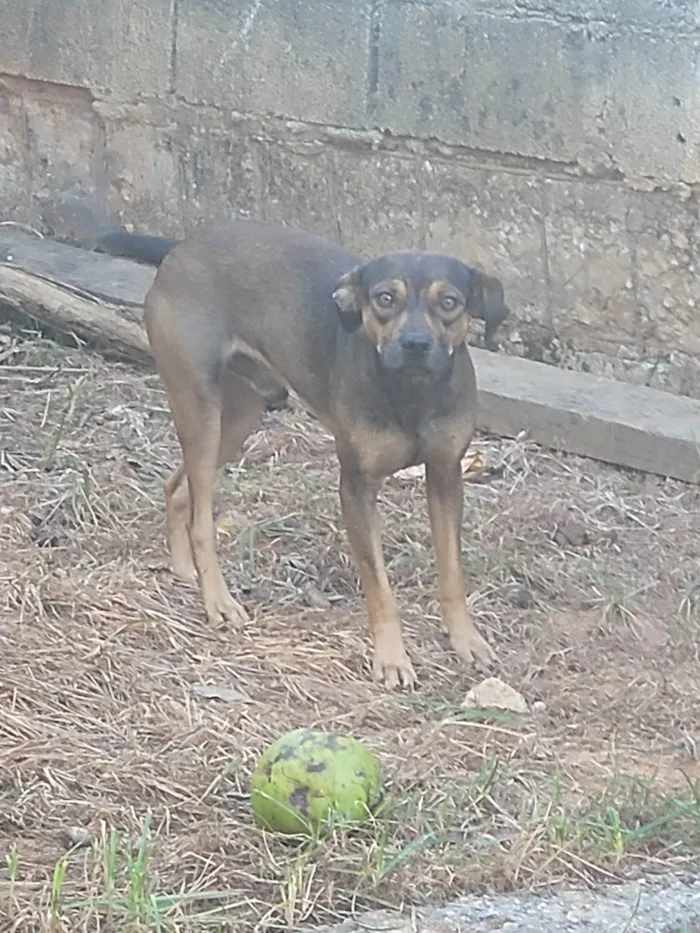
[101,220,508,687]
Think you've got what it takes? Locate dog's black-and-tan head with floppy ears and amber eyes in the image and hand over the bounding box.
[333,252,508,379]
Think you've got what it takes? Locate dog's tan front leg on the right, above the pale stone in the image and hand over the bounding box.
[425,460,496,664]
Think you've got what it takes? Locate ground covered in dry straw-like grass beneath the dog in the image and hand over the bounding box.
[0,324,700,933]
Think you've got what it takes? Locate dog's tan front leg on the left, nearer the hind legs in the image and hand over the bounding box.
[340,461,416,689]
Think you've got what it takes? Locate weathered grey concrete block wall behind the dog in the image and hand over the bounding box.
[0,0,700,396]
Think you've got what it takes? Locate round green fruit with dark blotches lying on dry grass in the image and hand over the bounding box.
[251,729,382,834]
